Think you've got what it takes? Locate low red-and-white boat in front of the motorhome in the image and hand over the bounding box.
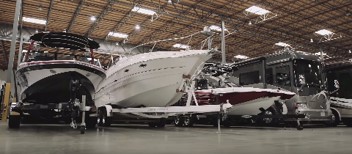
[195,87,295,116]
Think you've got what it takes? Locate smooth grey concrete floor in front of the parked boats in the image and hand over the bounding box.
[0,123,352,154]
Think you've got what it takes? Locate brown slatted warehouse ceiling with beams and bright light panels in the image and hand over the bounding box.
[0,0,352,69]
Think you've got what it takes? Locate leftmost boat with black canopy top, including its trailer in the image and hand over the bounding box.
[9,32,105,128]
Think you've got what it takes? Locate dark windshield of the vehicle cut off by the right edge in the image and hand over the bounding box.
[327,66,352,99]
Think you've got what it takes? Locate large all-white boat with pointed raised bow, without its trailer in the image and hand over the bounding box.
[95,50,211,107]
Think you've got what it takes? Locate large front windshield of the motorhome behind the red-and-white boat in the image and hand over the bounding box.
[293,59,323,90]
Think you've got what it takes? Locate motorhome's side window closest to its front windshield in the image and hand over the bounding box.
[276,66,291,86]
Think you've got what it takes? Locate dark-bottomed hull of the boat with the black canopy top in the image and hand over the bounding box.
[16,61,105,104]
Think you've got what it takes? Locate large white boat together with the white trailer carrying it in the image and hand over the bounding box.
[95,50,231,127]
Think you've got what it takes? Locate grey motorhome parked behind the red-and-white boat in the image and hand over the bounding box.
[230,48,333,125]
